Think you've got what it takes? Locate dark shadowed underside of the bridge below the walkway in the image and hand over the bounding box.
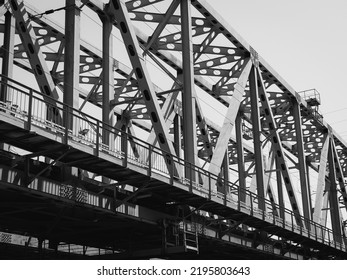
[0,112,345,259]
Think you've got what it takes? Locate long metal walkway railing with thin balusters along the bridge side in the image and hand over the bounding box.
[0,76,345,250]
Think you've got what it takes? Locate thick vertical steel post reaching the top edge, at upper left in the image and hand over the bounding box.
[64,0,80,131]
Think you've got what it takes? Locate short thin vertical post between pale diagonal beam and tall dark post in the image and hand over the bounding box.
[235,111,246,202]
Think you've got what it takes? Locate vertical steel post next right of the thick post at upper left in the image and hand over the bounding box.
[101,9,115,149]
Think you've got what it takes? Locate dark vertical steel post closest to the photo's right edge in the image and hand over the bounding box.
[328,141,342,243]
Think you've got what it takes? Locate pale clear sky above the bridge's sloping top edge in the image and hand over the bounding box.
[26,0,347,141]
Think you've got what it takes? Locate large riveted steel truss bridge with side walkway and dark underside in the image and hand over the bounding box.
[0,0,347,259]
